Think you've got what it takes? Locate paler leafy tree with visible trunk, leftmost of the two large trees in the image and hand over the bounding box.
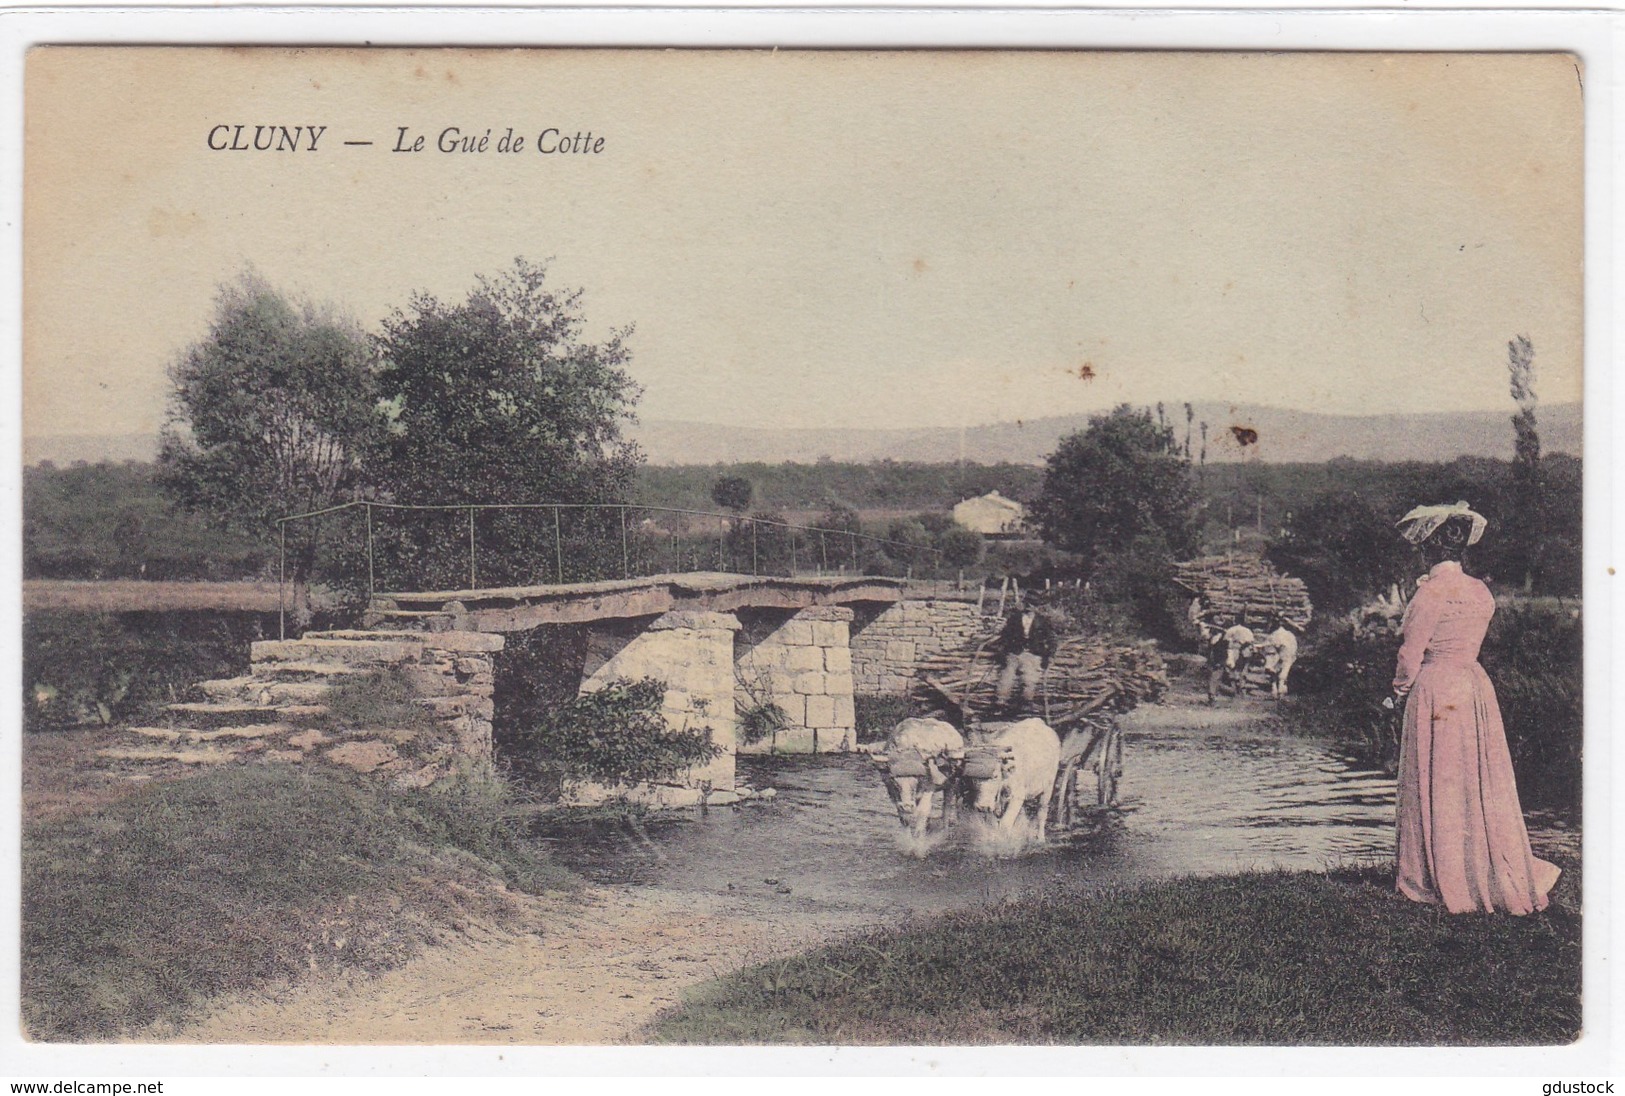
[158,272,384,623]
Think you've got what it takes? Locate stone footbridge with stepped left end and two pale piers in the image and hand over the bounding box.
[136,572,978,805]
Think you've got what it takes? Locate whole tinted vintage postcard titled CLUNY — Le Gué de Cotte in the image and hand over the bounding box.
[12,46,1589,1066]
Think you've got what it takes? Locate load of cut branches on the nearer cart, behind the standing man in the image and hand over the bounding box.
[910,636,1168,732]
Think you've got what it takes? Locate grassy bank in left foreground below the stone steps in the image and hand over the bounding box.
[21,754,575,1041]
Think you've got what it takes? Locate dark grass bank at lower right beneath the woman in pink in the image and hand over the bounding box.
[650,870,1581,1046]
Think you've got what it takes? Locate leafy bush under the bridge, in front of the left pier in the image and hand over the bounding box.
[518,678,722,784]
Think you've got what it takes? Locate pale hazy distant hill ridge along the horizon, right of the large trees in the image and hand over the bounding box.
[632,403,1581,465]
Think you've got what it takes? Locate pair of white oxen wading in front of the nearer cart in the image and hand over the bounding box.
[871,719,1061,839]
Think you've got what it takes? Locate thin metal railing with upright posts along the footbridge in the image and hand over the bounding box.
[276,499,943,597]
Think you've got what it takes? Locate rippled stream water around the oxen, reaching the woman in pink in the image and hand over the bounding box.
[536,709,1394,916]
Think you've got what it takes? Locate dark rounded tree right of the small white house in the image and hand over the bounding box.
[1034,403,1196,569]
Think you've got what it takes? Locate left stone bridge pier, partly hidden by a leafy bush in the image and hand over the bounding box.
[564,610,739,807]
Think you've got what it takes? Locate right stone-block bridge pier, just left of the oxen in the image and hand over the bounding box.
[736,607,856,753]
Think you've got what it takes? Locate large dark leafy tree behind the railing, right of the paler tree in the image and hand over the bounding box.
[377,259,640,582]
